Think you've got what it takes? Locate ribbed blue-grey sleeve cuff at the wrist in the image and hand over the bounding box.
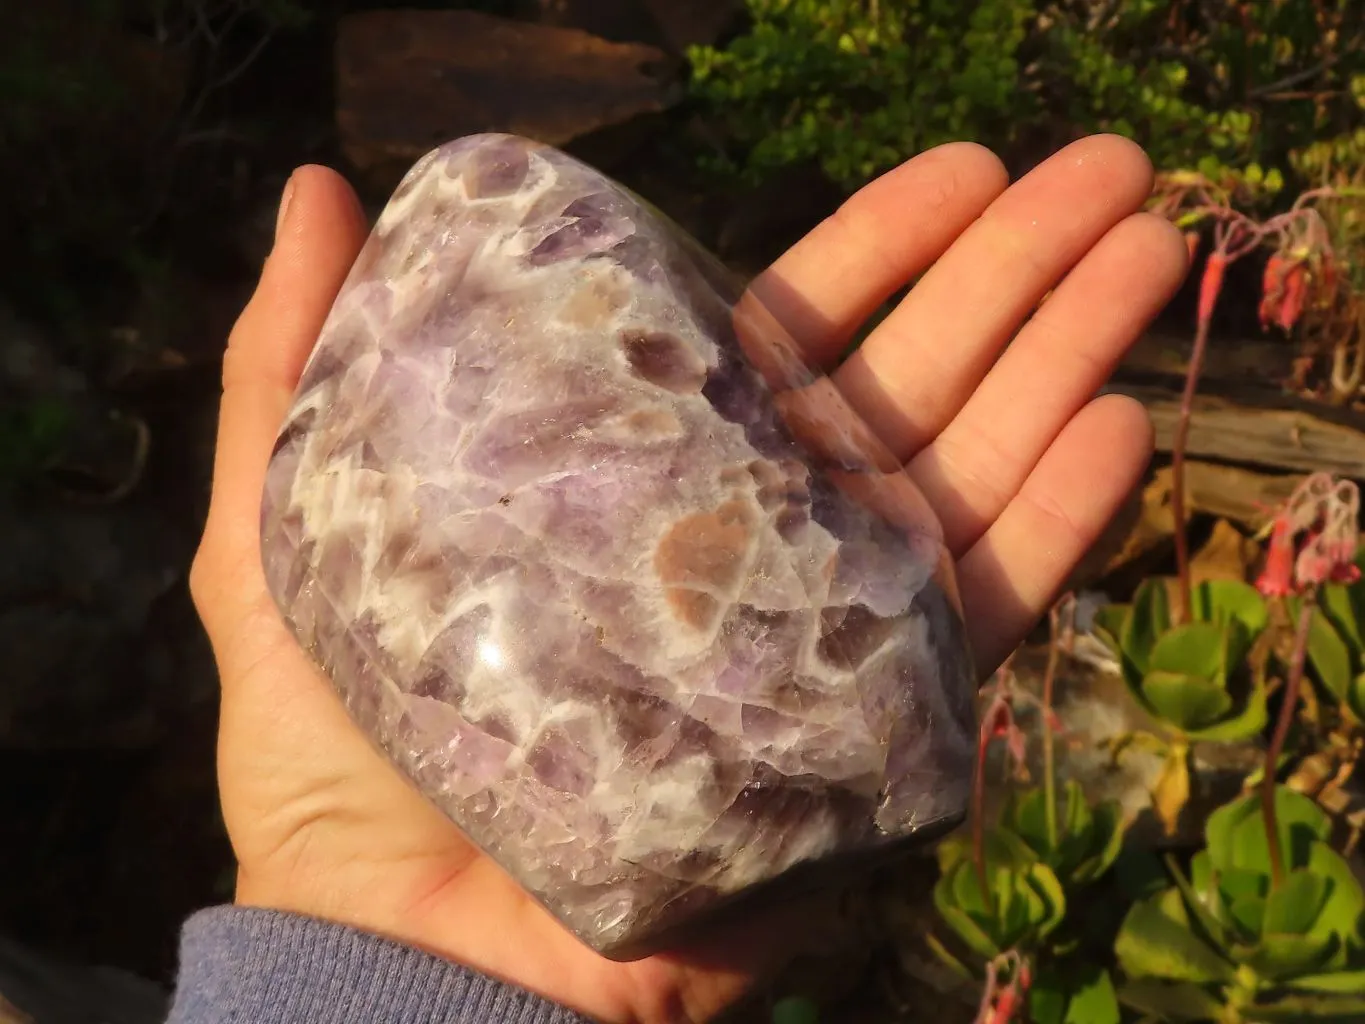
[167,907,587,1024]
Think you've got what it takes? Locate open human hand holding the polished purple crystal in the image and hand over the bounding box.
[191,137,1186,1024]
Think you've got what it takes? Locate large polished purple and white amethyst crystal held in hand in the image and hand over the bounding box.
[262,135,976,957]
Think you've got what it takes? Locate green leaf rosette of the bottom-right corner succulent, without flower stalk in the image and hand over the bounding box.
[1115,786,1365,1024]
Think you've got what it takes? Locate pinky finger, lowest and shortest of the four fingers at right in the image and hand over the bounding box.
[957,395,1152,676]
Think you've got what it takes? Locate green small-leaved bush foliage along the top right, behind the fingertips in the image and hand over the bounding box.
[689,0,1365,194]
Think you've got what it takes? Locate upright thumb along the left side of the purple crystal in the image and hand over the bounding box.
[190,165,366,677]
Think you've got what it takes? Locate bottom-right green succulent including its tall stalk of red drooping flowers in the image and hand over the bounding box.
[1114,474,1365,1024]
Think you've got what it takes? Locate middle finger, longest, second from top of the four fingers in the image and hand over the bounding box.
[833,135,1152,460]
